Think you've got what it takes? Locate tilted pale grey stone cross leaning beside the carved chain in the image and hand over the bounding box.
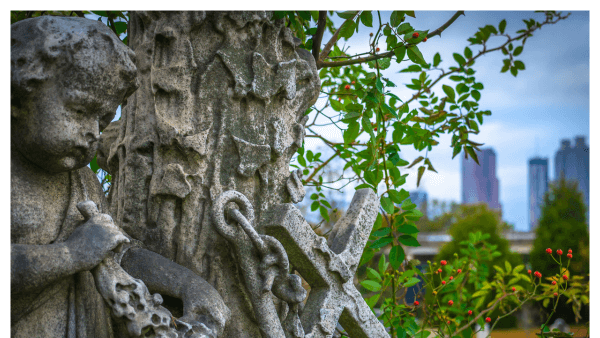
[263,189,389,338]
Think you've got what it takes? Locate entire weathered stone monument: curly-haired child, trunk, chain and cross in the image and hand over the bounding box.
[11,12,388,338]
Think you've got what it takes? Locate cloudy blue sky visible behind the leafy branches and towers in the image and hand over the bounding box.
[298,11,590,231]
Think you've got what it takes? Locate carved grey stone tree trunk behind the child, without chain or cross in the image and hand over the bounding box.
[99,12,320,337]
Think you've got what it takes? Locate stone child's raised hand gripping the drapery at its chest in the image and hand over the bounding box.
[65,213,129,271]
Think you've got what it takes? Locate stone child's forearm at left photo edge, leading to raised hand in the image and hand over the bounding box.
[10,243,80,294]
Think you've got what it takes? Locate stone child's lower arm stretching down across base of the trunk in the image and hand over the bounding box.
[121,248,230,332]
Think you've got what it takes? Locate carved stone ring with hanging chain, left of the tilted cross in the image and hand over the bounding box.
[212,190,306,338]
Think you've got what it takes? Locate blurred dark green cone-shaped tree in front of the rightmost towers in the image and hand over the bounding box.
[530,179,590,322]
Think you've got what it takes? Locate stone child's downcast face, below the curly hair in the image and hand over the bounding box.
[11,75,120,172]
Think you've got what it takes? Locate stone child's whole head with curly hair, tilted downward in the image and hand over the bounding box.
[10,16,139,172]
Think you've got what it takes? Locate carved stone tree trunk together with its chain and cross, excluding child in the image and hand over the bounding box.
[98,12,387,338]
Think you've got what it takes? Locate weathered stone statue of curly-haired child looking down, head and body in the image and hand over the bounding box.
[11,17,230,338]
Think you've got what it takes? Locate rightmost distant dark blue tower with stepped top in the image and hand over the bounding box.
[554,136,590,217]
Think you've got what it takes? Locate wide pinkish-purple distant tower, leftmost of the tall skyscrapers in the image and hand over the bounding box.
[462,148,501,210]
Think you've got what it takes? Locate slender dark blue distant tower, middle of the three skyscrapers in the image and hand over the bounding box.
[529,158,548,231]
